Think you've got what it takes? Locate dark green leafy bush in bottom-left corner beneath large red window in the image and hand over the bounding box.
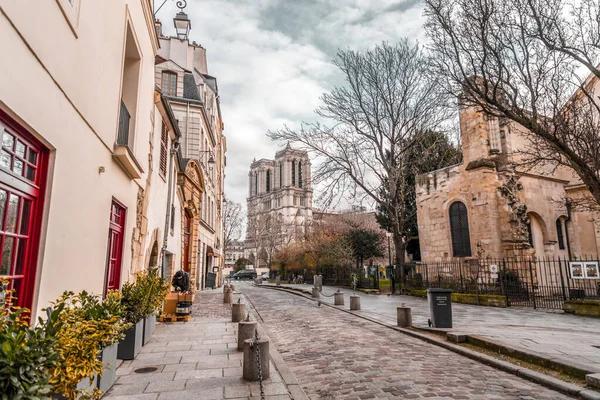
[0,281,60,400]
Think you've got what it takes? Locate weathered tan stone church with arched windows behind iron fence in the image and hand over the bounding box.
[416,101,600,262]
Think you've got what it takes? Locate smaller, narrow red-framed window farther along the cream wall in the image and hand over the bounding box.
[104,199,127,294]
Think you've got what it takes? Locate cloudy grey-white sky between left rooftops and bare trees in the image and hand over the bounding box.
[155,0,424,206]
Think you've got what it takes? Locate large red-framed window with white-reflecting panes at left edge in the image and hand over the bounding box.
[0,110,50,310]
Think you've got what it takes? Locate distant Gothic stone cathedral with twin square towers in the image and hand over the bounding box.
[244,144,313,266]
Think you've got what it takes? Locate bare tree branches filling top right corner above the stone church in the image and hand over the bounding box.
[425,0,600,207]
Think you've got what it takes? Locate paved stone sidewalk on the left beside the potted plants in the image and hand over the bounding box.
[103,291,292,400]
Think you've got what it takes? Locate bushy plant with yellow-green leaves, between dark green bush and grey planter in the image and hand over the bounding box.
[50,291,131,400]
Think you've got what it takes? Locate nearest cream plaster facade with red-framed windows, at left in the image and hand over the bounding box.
[0,0,159,314]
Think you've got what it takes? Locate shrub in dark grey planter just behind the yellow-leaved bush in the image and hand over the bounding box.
[117,282,147,360]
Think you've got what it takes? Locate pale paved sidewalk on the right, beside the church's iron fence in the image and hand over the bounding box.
[270,284,600,372]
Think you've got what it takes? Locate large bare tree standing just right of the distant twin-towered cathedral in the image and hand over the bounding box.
[269,40,448,284]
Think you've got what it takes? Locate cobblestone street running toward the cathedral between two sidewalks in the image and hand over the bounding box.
[240,285,570,400]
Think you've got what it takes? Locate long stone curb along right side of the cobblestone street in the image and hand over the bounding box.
[257,285,600,400]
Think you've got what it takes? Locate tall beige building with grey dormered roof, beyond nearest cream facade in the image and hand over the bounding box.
[155,21,227,289]
